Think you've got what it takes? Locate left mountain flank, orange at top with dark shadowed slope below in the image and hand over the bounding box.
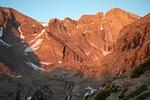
[0,8,43,75]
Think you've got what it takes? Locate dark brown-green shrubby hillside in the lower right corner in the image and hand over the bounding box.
[86,61,150,100]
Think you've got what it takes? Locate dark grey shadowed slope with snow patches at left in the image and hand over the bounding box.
[0,19,41,75]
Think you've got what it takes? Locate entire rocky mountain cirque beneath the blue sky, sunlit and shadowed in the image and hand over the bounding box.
[0,8,150,100]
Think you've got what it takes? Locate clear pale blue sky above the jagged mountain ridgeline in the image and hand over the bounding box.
[0,0,150,22]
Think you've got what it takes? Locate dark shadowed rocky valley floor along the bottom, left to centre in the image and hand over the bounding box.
[0,66,96,100]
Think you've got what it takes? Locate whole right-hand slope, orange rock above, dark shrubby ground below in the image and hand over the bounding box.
[86,15,150,100]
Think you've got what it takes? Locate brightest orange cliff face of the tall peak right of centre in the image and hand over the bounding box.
[77,8,140,51]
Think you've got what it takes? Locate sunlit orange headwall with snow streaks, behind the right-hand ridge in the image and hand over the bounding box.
[0,8,140,74]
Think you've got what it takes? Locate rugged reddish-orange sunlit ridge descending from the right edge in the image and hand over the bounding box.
[97,15,150,74]
